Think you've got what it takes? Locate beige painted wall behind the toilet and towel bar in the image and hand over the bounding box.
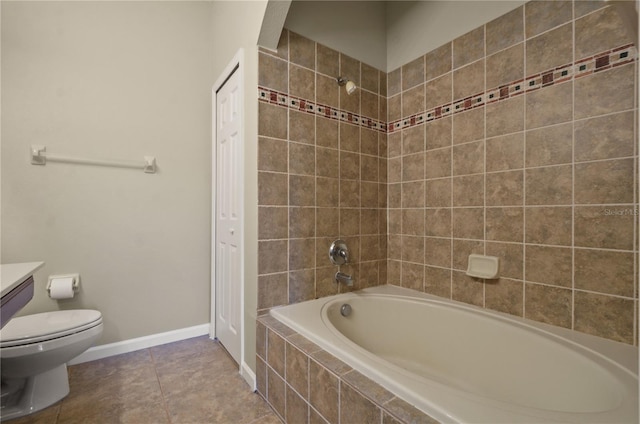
[1,2,215,343]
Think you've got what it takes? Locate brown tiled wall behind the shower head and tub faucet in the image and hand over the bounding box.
[258,30,387,311]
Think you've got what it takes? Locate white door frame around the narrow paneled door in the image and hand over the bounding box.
[209,48,246,373]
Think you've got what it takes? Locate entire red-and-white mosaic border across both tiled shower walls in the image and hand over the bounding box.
[258,44,638,133]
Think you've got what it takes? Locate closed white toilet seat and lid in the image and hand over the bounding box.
[0,309,102,348]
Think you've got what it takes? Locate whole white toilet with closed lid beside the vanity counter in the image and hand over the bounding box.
[0,309,102,421]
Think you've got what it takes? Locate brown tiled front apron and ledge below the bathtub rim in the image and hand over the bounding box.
[256,315,437,424]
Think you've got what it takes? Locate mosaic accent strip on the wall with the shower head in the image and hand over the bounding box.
[258,86,387,133]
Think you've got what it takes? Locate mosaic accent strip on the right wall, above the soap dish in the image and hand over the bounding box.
[388,44,638,133]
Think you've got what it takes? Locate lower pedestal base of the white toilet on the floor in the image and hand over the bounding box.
[0,364,69,421]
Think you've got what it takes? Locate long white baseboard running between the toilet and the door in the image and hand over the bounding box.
[68,323,210,364]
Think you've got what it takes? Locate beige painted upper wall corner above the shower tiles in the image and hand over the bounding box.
[285,0,525,72]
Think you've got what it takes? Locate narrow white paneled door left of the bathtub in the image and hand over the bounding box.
[214,68,243,364]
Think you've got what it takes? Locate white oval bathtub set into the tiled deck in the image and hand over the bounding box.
[271,286,638,423]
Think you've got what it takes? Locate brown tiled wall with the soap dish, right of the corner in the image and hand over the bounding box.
[387,1,638,345]
